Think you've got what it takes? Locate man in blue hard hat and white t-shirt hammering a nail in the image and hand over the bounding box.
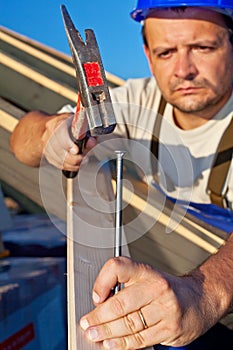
[11,0,233,350]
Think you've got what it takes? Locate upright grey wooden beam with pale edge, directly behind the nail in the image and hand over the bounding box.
[67,158,147,350]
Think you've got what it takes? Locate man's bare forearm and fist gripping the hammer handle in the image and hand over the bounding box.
[10,111,95,171]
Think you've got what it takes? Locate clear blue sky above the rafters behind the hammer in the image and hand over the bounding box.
[0,0,150,79]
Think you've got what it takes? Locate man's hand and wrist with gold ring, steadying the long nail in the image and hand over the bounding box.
[80,234,233,350]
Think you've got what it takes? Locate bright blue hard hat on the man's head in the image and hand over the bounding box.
[130,0,233,22]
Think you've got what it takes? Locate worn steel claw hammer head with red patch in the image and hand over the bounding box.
[61,5,116,136]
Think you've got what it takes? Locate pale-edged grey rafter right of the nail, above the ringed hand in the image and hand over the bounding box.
[123,178,227,274]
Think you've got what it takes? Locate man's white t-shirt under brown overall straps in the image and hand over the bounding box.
[60,77,233,208]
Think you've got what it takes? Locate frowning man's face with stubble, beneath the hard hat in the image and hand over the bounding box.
[145,8,233,118]
